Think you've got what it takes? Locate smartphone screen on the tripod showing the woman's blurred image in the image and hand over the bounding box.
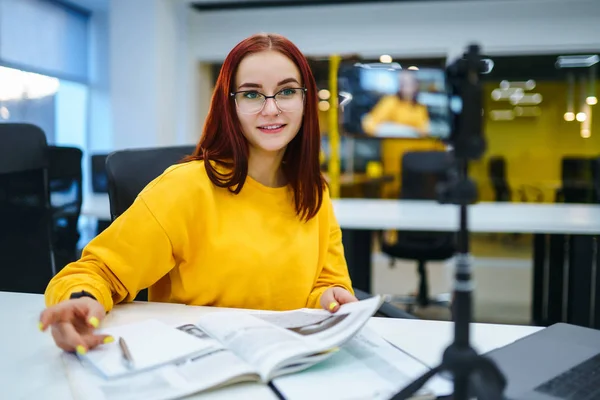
[339,64,452,139]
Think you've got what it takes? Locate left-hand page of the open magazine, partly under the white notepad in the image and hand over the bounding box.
[62,324,260,400]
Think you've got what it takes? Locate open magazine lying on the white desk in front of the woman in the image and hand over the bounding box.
[63,296,382,400]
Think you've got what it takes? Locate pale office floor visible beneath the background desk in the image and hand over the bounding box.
[372,234,532,325]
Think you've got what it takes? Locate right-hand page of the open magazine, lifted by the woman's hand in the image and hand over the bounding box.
[197,296,381,382]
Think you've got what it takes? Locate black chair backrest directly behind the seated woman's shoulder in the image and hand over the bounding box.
[106,146,195,221]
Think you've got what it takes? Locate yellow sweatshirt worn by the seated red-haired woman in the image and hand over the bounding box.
[45,161,353,311]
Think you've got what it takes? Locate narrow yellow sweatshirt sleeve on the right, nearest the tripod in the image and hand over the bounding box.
[307,191,354,308]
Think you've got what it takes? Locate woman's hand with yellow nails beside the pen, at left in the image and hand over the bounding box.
[39,297,114,354]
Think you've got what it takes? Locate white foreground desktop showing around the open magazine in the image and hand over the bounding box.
[0,292,539,400]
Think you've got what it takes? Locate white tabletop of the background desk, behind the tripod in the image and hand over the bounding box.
[333,199,600,234]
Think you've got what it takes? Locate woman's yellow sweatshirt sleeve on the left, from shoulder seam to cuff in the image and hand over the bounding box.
[45,198,175,311]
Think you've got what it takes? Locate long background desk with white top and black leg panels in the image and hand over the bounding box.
[333,199,600,328]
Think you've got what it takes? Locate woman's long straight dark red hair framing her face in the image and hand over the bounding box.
[188,34,325,221]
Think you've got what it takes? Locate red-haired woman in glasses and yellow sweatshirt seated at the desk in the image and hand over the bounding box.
[40,34,357,353]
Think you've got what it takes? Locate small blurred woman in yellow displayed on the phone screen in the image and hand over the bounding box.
[362,70,429,136]
